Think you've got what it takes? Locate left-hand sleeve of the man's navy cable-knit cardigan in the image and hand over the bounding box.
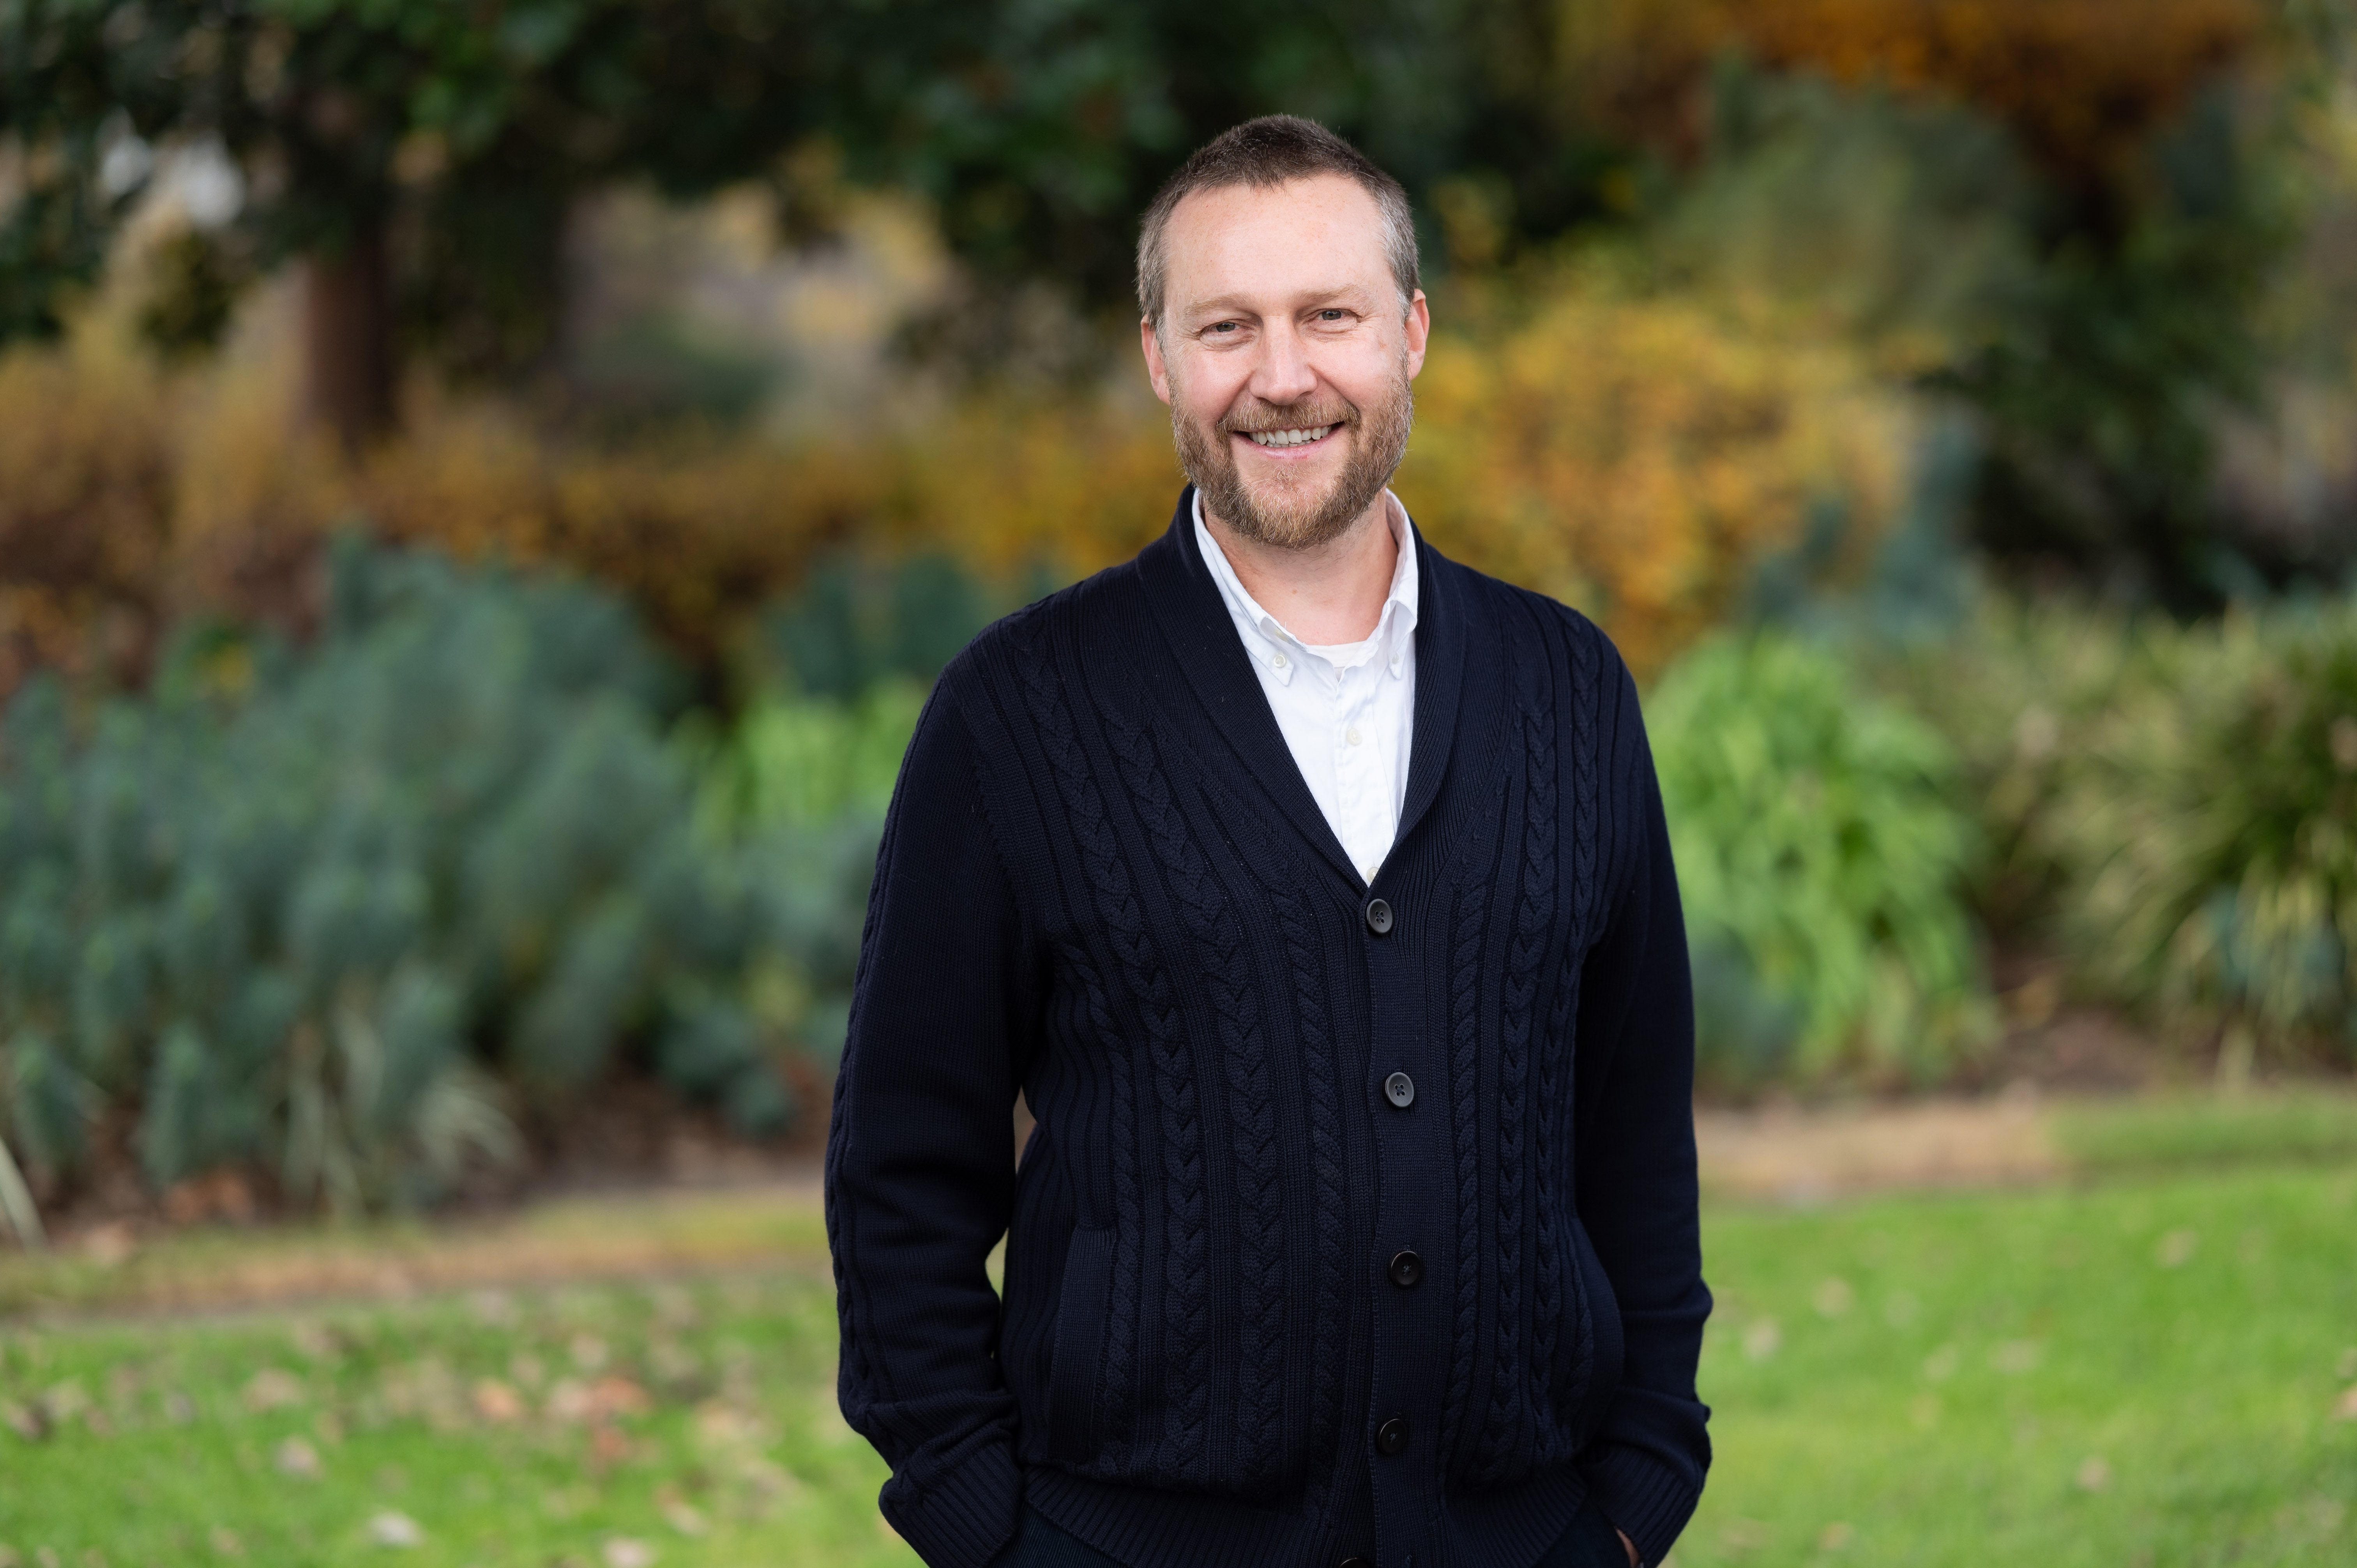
[827,693,1035,1568]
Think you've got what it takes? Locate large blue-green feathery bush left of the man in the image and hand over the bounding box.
[0,542,875,1210]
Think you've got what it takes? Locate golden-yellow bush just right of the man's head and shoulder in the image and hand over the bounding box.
[1398,282,1916,672]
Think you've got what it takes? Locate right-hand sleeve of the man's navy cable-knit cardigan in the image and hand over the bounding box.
[1574,660,1711,1563]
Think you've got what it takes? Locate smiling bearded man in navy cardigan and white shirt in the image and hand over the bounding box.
[827,118,1709,1568]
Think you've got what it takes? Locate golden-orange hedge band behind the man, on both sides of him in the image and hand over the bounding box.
[0,283,1907,691]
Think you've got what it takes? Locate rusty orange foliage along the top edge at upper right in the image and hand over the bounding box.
[1563,0,2270,175]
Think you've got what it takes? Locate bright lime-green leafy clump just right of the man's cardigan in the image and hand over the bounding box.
[1648,632,1987,1089]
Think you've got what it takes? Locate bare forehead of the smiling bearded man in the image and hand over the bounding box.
[1162,175,1391,311]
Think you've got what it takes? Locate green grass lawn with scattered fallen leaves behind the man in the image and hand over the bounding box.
[0,1158,2357,1568]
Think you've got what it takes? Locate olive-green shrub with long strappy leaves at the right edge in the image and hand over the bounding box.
[2041,601,2357,1077]
